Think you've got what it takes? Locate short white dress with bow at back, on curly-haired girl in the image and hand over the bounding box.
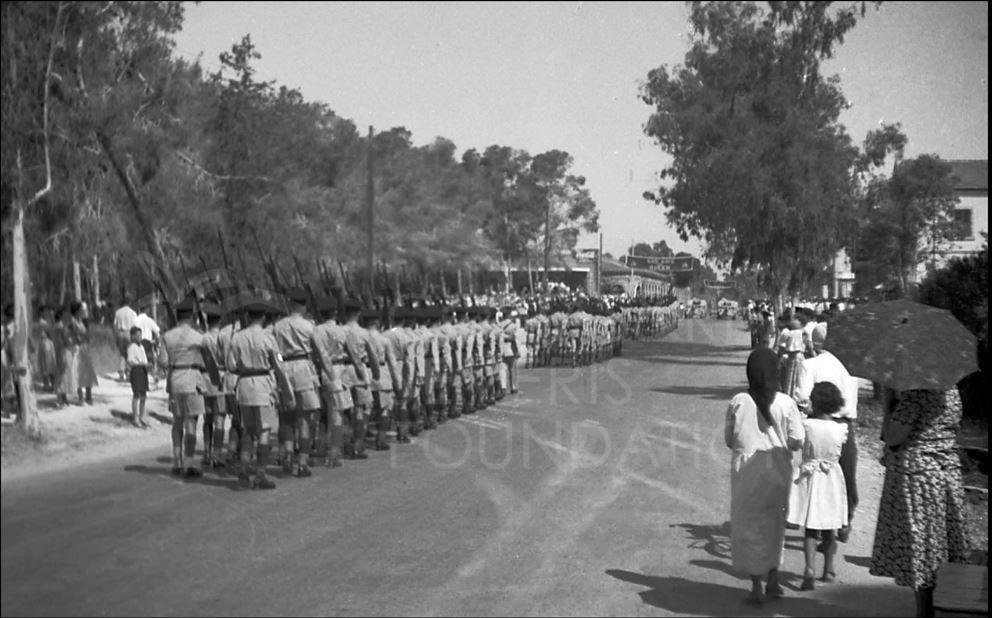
[789,418,847,530]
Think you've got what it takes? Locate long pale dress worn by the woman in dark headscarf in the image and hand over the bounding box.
[726,393,803,575]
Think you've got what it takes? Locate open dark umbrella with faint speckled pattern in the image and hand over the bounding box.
[824,300,978,390]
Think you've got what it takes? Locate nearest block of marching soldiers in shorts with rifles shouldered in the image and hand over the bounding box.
[159,289,536,489]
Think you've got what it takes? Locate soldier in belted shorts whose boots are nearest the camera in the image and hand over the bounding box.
[226,300,279,489]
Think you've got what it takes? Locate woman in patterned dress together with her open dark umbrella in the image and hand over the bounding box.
[825,300,978,617]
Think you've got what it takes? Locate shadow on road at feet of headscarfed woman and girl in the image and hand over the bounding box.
[606,569,884,616]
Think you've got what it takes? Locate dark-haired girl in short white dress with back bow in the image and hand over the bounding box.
[788,382,848,590]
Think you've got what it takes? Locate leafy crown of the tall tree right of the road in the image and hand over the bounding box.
[641,2,865,308]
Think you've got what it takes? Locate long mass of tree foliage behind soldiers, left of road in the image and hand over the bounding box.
[2,1,598,302]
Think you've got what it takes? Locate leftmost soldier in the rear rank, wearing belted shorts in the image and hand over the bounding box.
[159,298,206,478]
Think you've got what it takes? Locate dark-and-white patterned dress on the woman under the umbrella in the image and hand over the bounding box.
[869,389,966,589]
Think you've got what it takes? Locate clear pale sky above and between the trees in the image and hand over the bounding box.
[176,2,989,256]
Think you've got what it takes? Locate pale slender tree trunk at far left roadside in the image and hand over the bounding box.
[12,203,41,436]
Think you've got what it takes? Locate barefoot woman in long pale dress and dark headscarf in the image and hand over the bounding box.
[724,348,805,605]
